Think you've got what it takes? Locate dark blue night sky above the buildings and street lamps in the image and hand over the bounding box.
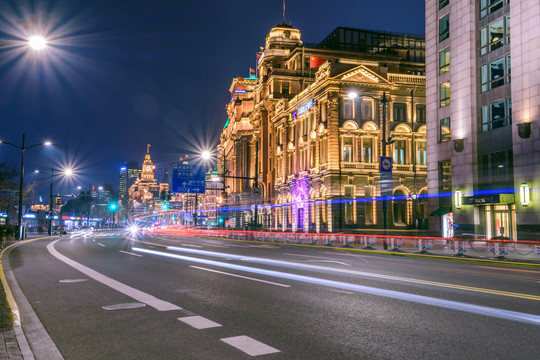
[0,0,424,201]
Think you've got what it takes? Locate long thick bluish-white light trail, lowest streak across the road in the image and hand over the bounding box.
[132,248,540,326]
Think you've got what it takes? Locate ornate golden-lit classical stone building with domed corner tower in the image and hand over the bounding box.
[218,24,427,232]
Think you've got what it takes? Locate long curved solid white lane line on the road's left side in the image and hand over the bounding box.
[47,240,182,311]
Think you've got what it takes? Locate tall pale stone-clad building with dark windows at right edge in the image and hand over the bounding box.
[426,0,540,239]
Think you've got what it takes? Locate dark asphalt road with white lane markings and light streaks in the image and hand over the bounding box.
[4,232,540,360]
